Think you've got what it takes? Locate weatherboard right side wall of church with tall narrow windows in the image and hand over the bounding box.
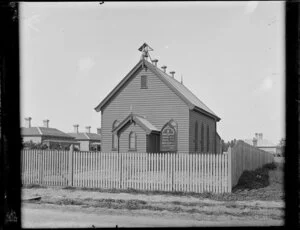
[189,110,216,152]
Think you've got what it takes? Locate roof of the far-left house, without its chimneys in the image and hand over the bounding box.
[21,127,73,139]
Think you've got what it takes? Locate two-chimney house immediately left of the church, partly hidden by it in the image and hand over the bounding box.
[68,124,101,151]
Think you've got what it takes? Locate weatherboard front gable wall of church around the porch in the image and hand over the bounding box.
[101,66,189,152]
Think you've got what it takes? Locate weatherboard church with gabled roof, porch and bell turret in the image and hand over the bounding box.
[95,43,221,153]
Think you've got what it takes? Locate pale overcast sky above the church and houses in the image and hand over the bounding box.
[20,2,285,144]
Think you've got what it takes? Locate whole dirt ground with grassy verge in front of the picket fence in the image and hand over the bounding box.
[22,188,284,228]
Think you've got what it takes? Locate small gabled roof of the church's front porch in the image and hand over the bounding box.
[112,113,160,134]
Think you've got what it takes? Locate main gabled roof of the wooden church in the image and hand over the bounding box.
[95,59,220,121]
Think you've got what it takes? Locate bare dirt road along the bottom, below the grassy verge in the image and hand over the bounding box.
[22,204,282,228]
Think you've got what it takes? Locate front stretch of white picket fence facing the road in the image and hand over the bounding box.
[21,150,231,193]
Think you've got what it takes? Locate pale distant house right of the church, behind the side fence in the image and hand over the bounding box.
[244,133,281,156]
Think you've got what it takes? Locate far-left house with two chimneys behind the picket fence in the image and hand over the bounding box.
[21,117,77,149]
